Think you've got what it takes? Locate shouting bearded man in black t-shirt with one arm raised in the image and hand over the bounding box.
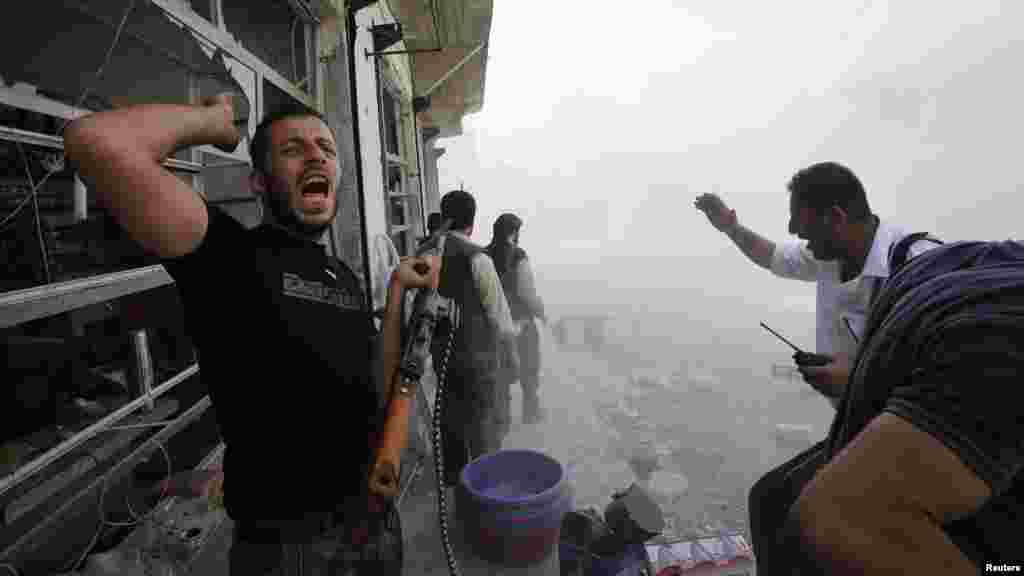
[66,91,427,575]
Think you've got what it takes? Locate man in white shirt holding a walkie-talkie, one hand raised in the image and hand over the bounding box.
[695,162,936,574]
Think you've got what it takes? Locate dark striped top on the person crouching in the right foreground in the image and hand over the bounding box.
[829,242,1024,566]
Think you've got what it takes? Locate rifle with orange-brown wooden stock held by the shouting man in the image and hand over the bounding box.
[370,220,452,500]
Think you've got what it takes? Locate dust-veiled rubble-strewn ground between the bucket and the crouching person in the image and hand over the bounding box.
[503,319,831,537]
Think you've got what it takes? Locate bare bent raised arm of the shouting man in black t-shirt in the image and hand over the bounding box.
[65,95,241,258]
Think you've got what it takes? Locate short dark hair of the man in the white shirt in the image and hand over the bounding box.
[786,162,871,222]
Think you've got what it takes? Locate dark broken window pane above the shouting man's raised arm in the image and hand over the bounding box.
[0,0,242,116]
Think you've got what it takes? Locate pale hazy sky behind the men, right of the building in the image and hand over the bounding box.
[439,0,1024,360]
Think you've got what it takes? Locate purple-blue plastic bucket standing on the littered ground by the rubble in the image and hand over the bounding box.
[456,450,572,567]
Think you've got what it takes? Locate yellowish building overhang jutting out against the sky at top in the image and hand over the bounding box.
[387,0,494,136]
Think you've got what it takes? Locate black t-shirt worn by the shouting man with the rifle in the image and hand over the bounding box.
[164,208,379,522]
